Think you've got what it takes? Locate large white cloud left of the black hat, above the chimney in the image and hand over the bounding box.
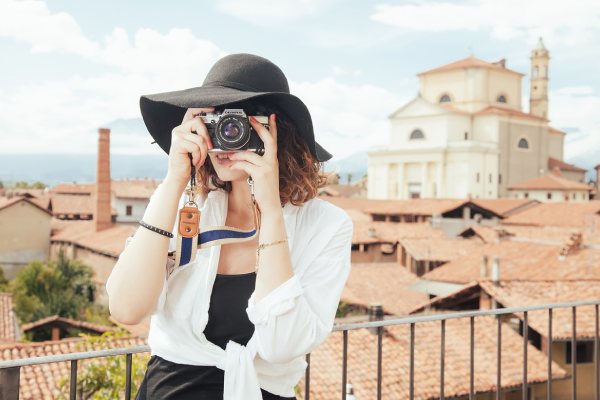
[0,0,226,153]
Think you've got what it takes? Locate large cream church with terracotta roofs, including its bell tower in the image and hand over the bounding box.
[368,38,580,199]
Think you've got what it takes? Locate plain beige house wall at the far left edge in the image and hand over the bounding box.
[0,201,52,279]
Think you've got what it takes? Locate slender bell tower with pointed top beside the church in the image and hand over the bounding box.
[529,37,550,118]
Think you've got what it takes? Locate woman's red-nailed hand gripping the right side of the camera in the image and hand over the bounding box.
[229,114,281,214]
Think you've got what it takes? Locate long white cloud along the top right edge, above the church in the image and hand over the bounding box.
[371,0,600,45]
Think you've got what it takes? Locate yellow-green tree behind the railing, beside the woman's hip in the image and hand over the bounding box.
[58,329,150,400]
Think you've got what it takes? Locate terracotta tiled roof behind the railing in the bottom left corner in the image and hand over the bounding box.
[0,337,147,400]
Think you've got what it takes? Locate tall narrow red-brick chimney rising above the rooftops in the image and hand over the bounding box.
[94,128,112,231]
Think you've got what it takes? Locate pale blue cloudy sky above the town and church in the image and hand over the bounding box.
[0,0,600,165]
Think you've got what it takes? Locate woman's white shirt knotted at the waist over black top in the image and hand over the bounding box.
[106,189,353,400]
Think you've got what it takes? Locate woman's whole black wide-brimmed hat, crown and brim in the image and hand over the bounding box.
[140,53,332,161]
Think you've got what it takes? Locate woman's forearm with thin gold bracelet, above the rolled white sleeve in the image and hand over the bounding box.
[254,208,294,302]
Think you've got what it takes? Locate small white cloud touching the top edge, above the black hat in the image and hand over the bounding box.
[216,0,334,27]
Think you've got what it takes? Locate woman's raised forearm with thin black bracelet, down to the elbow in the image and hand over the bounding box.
[107,178,185,323]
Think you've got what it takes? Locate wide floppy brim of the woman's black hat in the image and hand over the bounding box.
[140,86,332,161]
